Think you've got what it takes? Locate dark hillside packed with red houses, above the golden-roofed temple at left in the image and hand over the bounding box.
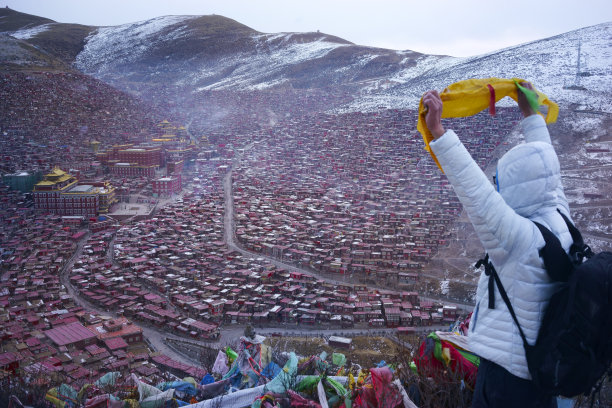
[0,72,161,178]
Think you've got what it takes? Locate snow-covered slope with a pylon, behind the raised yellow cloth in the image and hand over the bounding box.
[347,23,612,113]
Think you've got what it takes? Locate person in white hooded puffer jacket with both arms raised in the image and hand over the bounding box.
[423,83,572,408]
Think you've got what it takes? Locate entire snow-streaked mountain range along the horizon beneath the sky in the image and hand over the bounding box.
[0,7,612,112]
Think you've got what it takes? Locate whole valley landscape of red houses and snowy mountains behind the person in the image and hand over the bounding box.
[0,8,612,408]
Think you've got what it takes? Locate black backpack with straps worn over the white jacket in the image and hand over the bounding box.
[477,211,612,397]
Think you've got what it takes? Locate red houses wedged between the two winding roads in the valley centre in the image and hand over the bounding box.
[64,156,458,338]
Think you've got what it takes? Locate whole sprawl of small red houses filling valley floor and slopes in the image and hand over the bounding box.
[0,73,532,383]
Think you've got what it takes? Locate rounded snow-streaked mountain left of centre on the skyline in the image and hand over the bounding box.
[67,16,424,91]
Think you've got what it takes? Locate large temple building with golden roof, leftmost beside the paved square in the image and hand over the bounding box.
[33,167,117,217]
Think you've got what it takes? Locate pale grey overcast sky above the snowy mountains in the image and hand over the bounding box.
[0,0,612,57]
